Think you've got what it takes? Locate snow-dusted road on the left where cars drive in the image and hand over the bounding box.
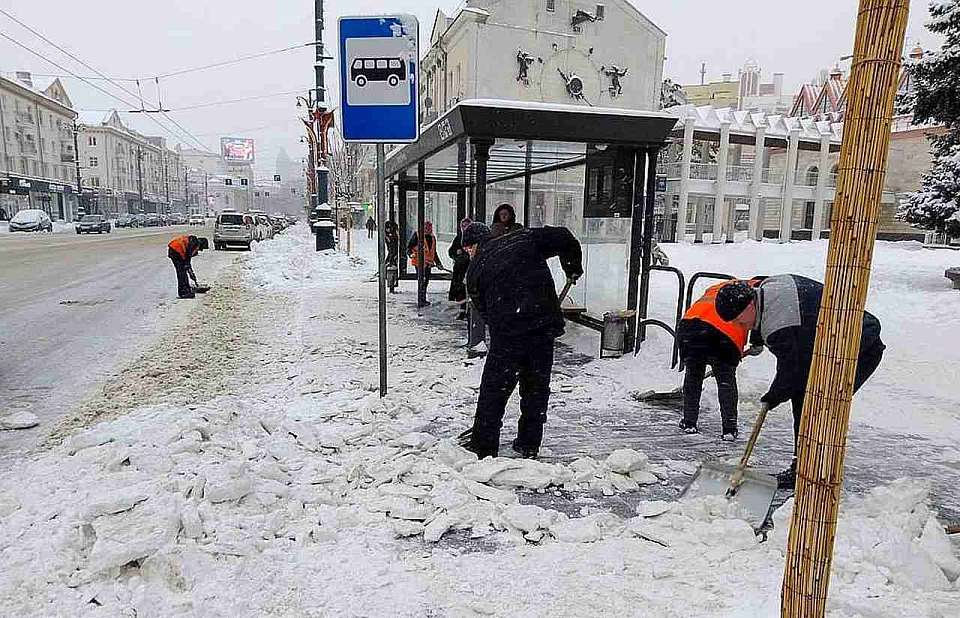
[0,227,236,456]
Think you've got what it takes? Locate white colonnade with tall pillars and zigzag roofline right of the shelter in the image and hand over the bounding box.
[660,105,843,242]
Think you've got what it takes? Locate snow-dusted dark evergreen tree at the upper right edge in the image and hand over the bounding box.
[898,0,960,235]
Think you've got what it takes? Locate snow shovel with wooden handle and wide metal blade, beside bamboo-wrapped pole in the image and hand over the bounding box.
[680,404,777,530]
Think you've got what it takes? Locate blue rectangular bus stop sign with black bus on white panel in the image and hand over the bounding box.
[339,15,420,144]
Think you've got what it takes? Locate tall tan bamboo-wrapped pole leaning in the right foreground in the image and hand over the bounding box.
[781,0,909,618]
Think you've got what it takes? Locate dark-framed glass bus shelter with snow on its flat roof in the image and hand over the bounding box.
[386,100,677,347]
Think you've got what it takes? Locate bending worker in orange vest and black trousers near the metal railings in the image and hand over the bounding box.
[677,279,763,442]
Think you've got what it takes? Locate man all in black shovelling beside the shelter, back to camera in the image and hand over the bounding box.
[463,223,583,458]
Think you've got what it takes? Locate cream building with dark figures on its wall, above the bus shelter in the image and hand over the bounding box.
[420,0,666,123]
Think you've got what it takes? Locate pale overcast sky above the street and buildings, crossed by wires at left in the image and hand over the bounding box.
[0,0,938,173]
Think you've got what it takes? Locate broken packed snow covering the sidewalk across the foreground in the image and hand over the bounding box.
[0,228,960,618]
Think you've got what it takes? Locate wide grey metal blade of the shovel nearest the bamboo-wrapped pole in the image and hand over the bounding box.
[680,461,777,530]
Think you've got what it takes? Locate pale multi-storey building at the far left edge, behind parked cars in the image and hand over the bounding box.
[0,72,78,221]
